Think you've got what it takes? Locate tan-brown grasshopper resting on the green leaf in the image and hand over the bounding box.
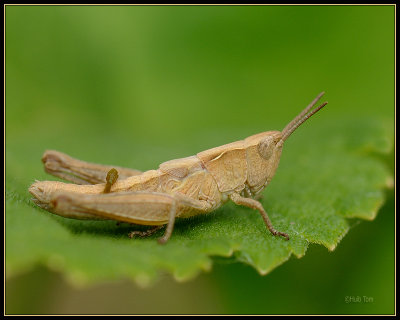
[29,92,327,243]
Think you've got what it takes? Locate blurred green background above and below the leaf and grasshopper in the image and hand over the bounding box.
[6,6,394,314]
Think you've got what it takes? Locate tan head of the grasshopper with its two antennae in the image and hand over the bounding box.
[245,92,327,195]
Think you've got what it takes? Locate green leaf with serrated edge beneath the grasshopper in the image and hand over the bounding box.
[6,117,393,286]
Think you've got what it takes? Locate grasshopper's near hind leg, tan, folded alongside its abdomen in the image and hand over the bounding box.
[49,191,212,244]
